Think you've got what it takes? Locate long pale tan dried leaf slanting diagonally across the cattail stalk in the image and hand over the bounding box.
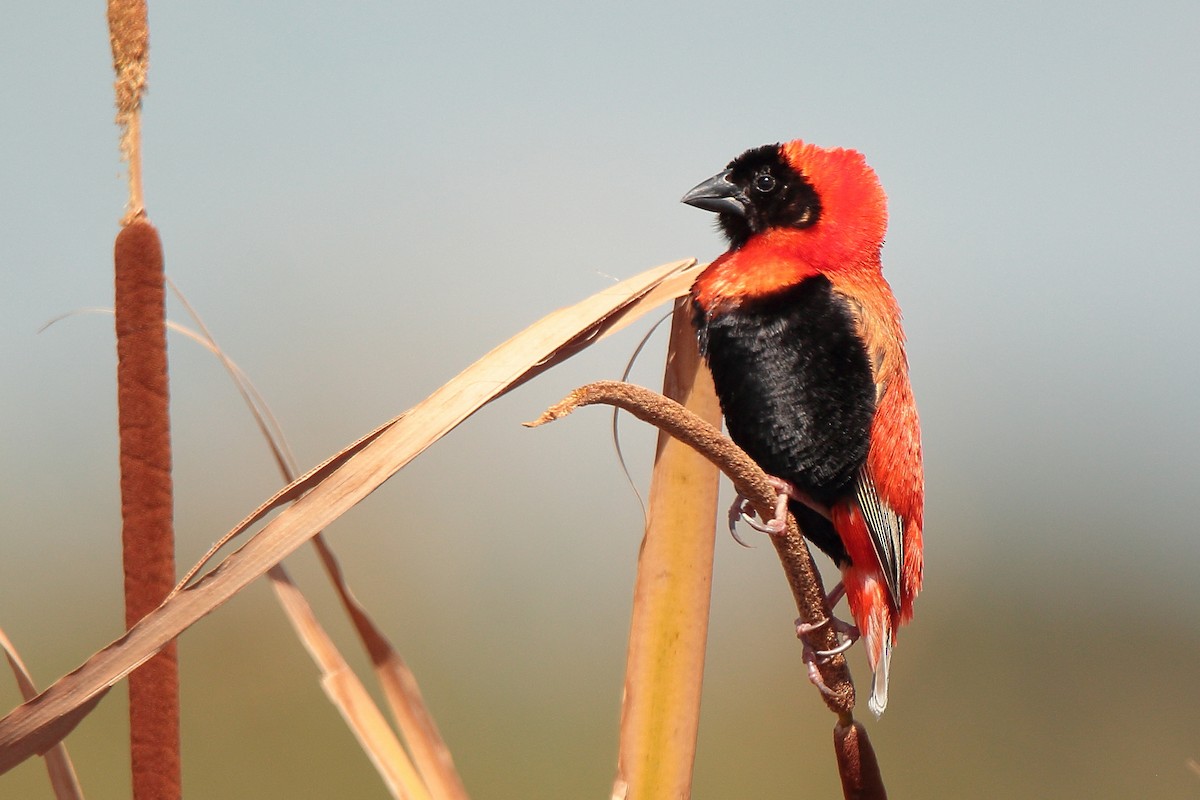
[0,260,700,772]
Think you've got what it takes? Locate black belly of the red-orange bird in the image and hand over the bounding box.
[692,276,875,563]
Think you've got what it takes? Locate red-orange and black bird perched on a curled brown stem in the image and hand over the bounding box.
[683,139,924,716]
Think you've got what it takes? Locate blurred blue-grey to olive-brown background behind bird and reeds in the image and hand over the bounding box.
[0,0,1200,799]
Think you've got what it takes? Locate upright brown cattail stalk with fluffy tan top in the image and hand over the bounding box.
[108,0,182,800]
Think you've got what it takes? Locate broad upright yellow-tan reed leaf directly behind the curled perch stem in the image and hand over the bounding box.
[613,300,721,798]
